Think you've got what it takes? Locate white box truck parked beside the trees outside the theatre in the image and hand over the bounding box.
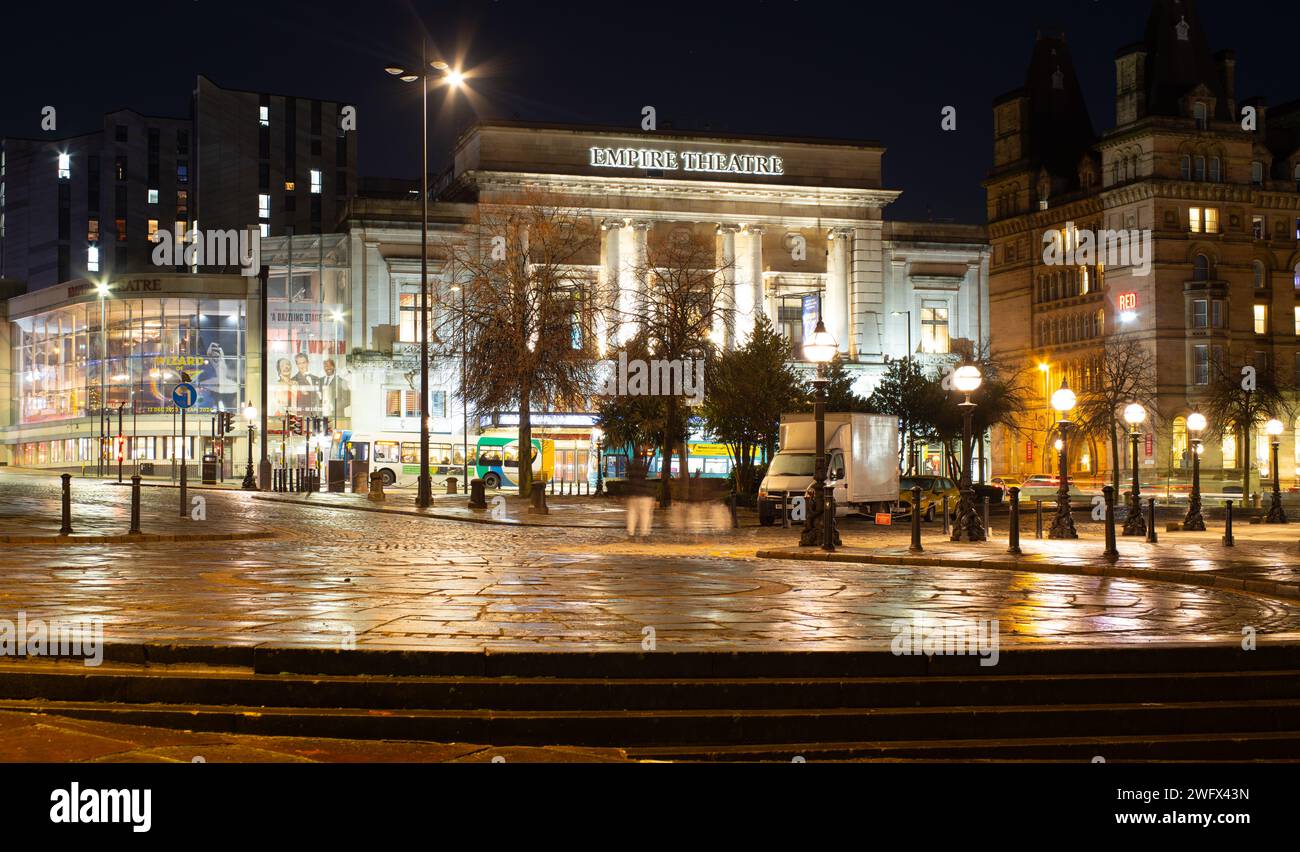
[758,414,898,527]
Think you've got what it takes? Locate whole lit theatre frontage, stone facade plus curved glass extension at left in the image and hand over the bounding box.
[0,122,988,481]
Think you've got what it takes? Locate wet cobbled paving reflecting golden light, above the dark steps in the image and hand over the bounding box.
[0,473,1300,650]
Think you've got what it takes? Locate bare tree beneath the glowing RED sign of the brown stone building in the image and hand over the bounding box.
[1075,336,1160,496]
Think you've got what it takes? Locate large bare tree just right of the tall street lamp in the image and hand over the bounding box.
[443,196,601,496]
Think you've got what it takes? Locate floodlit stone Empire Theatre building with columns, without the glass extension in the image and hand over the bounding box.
[343,122,987,483]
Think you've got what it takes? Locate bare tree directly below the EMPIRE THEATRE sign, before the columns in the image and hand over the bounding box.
[615,228,735,506]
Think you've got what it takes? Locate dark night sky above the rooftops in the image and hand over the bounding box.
[0,0,1300,221]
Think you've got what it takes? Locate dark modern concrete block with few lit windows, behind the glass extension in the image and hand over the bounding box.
[0,75,356,290]
